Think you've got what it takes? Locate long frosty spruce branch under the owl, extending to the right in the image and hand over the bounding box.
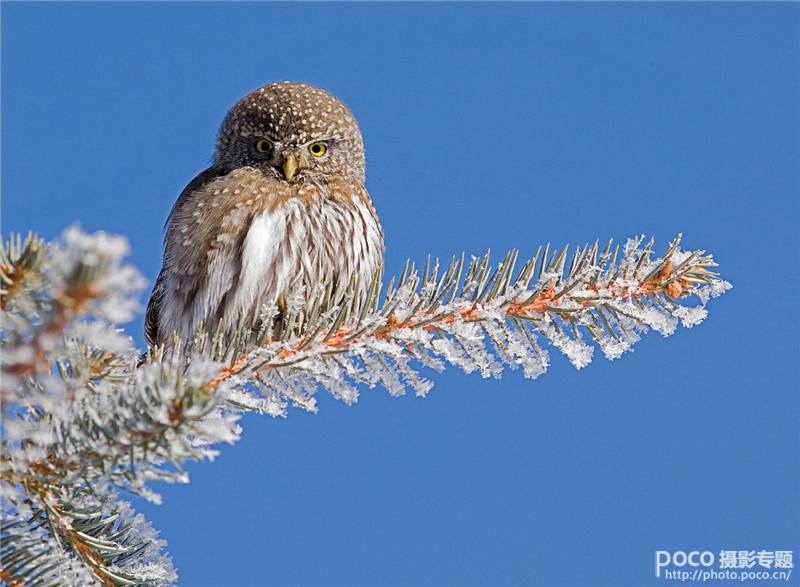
[211,237,730,414]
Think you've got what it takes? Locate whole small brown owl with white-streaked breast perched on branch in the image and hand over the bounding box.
[145,82,384,352]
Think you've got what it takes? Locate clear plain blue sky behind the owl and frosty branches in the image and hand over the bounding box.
[0,2,800,586]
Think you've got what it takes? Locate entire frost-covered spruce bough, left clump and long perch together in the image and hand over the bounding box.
[0,228,730,586]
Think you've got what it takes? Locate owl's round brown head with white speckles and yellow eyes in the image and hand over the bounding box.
[214,82,366,183]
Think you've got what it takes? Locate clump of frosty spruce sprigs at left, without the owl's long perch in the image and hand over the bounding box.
[0,228,238,586]
